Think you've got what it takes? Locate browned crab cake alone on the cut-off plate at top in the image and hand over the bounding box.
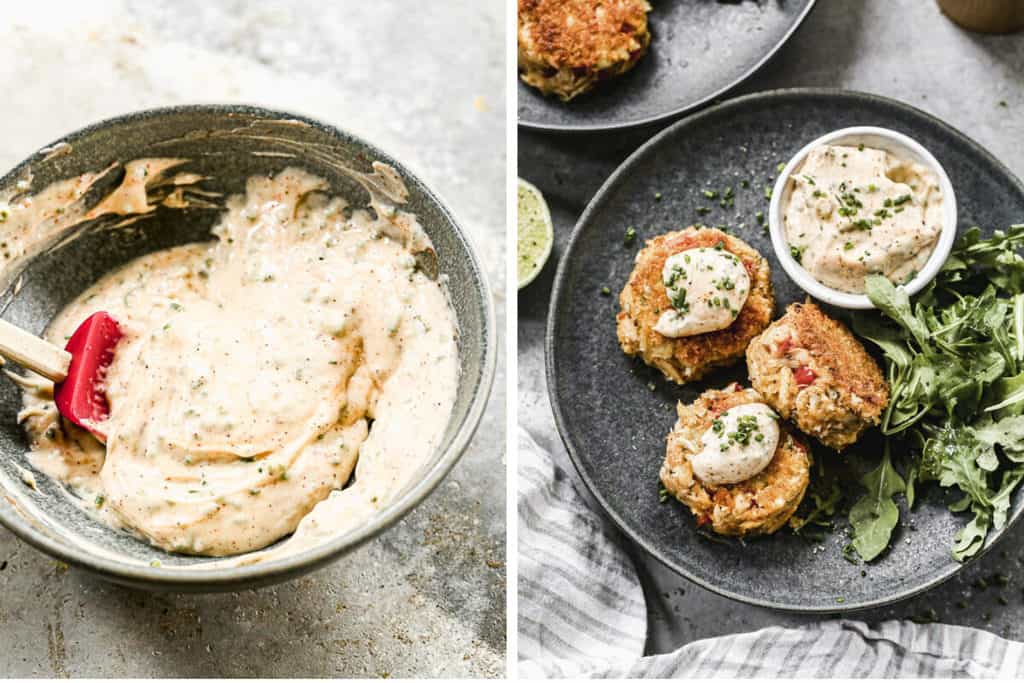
[518,0,650,101]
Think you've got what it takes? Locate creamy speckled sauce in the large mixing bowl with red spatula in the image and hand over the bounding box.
[22,169,459,563]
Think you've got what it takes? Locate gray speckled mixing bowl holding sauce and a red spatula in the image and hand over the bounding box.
[0,105,496,591]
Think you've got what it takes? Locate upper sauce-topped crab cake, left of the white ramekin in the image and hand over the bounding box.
[616,227,774,384]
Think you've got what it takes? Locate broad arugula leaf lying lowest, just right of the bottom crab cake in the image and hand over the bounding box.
[850,441,906,562]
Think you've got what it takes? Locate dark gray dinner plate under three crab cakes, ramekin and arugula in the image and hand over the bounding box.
[546,89,1024,612]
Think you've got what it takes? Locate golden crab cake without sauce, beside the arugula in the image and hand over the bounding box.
[746,302,889,451]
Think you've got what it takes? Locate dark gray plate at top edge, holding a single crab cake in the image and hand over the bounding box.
[518,0,814,132]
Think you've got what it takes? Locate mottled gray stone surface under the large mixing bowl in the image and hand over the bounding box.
[0,0,506,678]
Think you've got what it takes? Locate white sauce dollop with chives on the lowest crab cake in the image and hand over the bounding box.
[690,403,779,485]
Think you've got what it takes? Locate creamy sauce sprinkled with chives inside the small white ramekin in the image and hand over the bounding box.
[782,145,943,294]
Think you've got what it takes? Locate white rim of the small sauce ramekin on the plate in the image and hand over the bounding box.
[768,126,957,310]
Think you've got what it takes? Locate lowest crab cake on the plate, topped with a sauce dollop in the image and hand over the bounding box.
[662,384,811,536]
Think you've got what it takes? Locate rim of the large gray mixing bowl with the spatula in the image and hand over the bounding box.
[0,103,498,592]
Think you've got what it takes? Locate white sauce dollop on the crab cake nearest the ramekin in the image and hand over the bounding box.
[654,247,751,337]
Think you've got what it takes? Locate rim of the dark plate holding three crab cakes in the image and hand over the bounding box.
[544,87,1024,614]
